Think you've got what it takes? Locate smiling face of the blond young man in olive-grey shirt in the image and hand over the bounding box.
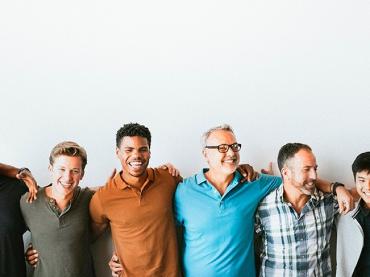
[49,155,84,197]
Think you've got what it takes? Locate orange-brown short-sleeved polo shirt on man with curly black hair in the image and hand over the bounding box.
[90,168,180,277]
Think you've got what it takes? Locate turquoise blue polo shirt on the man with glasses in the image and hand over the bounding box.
[174,169,281,277]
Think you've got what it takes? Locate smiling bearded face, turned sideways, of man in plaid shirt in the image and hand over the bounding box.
[282,149,317,195]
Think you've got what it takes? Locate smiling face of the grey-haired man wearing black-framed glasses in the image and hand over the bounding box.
[203,130,240,175]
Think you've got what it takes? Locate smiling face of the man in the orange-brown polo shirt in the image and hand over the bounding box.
[116,136,150,177]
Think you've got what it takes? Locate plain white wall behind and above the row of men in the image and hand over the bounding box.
[0,0,370,274]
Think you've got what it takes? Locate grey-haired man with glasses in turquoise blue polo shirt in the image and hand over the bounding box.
[174,125,281,277]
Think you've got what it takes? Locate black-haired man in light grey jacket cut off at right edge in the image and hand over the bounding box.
[337,152,370,277]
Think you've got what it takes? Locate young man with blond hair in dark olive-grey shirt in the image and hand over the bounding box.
[20,141,93,277]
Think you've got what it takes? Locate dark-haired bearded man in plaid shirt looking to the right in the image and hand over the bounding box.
[256,143,354,277]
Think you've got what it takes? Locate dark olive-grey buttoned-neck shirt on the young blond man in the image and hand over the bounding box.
[20,187,93,277]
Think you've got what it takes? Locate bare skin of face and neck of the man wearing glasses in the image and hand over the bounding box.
[203,130,240,195]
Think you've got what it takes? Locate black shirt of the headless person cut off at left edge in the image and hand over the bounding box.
[0,176,27,277]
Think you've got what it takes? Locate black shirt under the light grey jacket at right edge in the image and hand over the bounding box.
[353,200,370,277]
